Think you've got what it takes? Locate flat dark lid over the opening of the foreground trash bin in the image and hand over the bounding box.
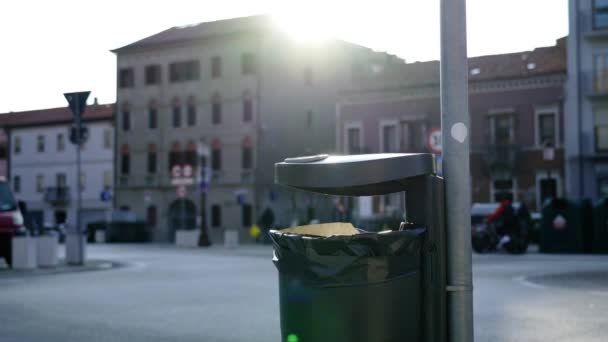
[275,153,436,196]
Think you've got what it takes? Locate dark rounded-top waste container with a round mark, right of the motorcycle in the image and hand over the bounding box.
[539,198,584,253]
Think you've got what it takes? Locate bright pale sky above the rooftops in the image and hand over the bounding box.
[0,0,568,113]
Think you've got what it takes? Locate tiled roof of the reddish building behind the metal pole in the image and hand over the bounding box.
[357,38,567,88]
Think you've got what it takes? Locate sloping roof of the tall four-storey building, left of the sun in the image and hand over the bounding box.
[112,15,271,53]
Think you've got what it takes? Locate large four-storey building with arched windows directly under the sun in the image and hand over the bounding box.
[114,16,391,241]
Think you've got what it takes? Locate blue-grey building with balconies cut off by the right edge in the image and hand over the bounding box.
[566,0,608,199]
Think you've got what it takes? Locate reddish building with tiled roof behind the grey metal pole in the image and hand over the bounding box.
[336,39,566,216]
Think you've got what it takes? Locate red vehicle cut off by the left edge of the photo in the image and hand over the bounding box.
[0,181,23,266]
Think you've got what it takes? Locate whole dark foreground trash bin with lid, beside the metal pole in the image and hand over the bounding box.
[271,153,446,342]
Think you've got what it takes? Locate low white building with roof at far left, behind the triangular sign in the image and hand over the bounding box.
[0,104,114,227]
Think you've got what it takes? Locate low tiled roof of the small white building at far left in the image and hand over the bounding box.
[0,103,115,127]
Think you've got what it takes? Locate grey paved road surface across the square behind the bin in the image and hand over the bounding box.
[0,245,608,342]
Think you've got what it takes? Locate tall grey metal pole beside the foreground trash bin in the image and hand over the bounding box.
[440,0,474,342]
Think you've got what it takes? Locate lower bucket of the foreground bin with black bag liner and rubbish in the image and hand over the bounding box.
[270,223,426,342]
